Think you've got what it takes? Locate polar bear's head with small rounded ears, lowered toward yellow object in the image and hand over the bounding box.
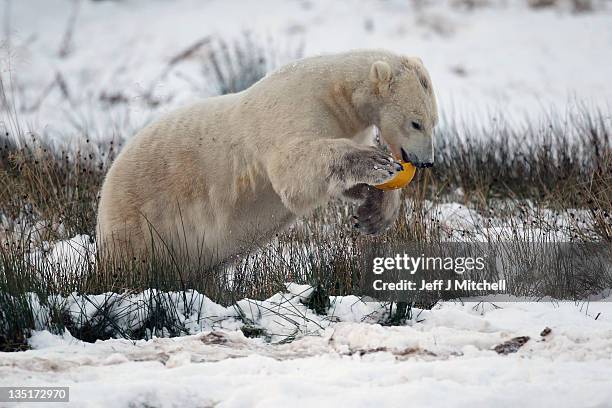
[353,57,438,167]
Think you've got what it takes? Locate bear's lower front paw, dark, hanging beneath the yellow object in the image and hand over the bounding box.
[352,187,399,235]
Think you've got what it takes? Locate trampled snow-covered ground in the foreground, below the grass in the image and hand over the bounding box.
[0,287,612,407]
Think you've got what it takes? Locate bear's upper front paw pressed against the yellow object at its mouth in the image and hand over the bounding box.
[340,147,403,185]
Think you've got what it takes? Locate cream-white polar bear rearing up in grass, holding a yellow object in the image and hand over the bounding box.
[97,50,438,262]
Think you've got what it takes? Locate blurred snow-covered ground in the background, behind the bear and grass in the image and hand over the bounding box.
[0,0,612,138]
